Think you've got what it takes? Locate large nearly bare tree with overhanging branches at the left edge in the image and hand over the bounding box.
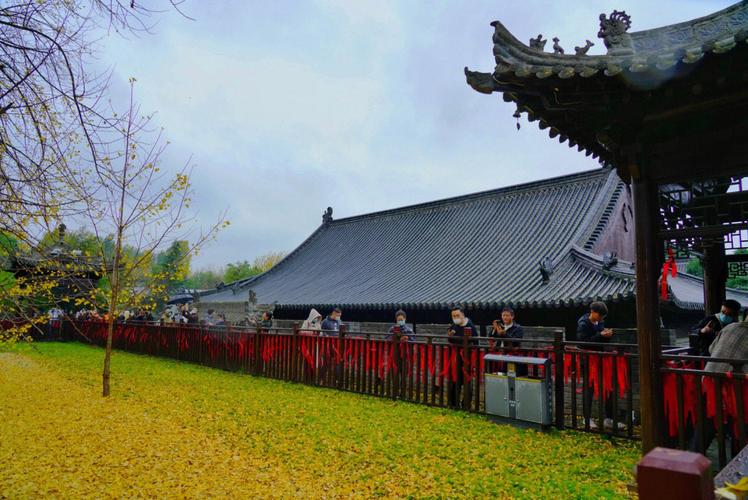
[0,0,196,342]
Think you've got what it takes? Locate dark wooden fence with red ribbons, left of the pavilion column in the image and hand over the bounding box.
[51,321,638,438]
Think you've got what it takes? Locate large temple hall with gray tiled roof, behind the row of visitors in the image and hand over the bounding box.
[199,169,748,332]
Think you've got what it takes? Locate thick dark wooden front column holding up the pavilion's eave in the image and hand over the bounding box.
[632,175,664,453]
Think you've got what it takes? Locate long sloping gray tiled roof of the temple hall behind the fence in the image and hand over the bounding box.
[200,169,634,309]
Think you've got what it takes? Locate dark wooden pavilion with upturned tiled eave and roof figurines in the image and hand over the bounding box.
[465,1,748,452]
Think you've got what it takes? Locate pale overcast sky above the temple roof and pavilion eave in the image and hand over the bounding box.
[101,0,733,269]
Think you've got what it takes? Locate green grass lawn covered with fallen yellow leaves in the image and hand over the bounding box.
[0,343,639,498]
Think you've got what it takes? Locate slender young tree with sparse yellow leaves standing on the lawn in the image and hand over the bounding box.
[70,78,229,396]
